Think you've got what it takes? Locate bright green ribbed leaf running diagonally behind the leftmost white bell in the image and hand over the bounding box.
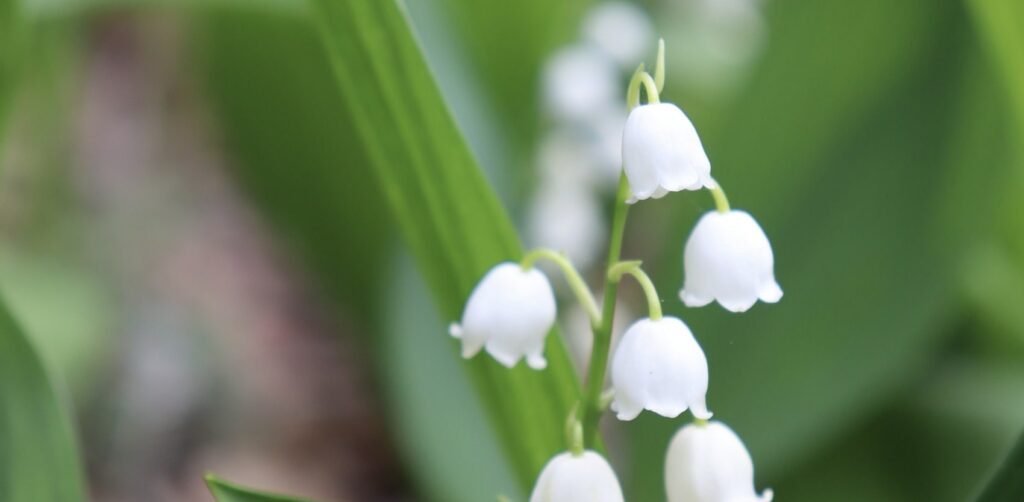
[307,0,578,487]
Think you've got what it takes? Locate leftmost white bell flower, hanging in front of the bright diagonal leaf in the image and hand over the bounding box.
[449,262,555,370]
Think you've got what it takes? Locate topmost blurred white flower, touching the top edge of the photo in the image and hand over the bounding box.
[583,2,653,70]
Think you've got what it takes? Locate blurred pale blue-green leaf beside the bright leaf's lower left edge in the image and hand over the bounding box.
[379,255,525,502]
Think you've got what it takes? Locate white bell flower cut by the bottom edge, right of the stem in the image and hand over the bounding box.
[665,421,773,502]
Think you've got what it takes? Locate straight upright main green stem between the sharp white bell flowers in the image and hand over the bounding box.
[583,173,630,445]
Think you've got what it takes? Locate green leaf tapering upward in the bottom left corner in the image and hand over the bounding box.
[0,297,85,502]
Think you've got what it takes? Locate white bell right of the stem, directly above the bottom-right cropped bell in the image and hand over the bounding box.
[611,318,711,420]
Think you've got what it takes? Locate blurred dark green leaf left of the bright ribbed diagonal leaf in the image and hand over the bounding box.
[198,8,391,324]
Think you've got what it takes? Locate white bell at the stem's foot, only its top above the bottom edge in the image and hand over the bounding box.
[529,450,625,502]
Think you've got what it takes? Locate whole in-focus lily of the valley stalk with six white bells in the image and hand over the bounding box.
[450,43,782,502]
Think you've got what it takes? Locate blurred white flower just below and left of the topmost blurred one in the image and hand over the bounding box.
[543,46,622,122]
